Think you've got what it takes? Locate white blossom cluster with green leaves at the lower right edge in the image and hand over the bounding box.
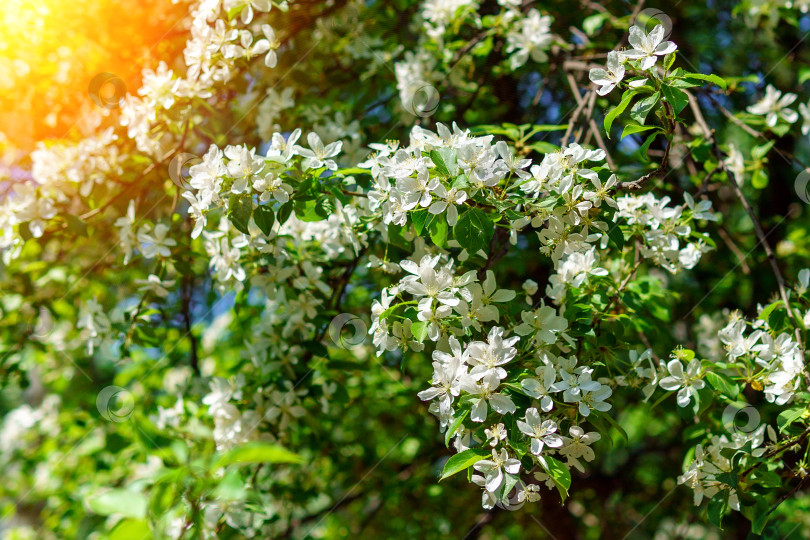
[658,269,810,524]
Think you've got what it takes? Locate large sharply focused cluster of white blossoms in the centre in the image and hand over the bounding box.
[362,124,713,507]
